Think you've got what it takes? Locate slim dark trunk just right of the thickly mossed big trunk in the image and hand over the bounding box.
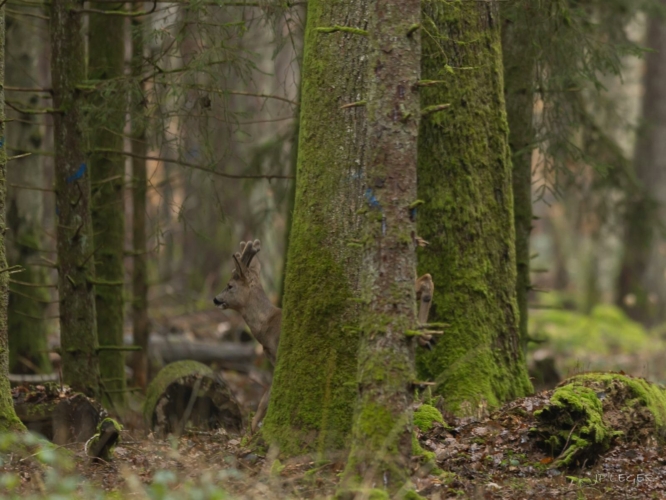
[501,0,536,352]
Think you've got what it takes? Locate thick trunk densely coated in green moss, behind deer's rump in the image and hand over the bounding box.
[417,0,532,414]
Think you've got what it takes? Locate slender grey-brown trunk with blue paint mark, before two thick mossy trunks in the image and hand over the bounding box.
[346,0,421,496]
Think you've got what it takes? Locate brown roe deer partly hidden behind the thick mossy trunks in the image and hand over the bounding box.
[213,240,435,432]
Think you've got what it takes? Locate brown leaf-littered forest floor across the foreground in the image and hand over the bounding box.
[5,378,666,499]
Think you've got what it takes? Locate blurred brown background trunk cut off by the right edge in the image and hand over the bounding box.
[618,0,666,326]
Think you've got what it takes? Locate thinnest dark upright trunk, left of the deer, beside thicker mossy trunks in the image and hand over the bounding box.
[131,3,150,389]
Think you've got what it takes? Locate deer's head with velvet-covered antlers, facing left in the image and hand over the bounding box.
[213,240,263,313]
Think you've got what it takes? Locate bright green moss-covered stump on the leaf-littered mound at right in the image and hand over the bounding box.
[534,373,666,468]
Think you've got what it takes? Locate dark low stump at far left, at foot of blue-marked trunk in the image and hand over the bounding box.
[12,383,106,445]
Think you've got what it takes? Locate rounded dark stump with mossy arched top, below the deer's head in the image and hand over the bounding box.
[143,361,243,437]
